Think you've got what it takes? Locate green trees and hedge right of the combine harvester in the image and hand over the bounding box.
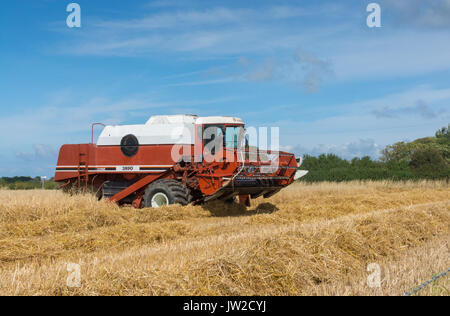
[302,125,450,182]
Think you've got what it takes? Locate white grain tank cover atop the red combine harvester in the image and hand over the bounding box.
[97,115,197,146]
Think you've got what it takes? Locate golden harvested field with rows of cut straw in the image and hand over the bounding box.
[0,182,450,295]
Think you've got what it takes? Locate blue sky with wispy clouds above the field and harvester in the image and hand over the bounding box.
[0,0,450,176]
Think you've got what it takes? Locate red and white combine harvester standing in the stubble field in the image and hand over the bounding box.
[51,115,307,208]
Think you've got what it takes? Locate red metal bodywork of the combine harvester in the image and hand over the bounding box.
[55,144,297,207]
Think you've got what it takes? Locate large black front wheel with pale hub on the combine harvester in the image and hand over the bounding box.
[144,179,190,208]
